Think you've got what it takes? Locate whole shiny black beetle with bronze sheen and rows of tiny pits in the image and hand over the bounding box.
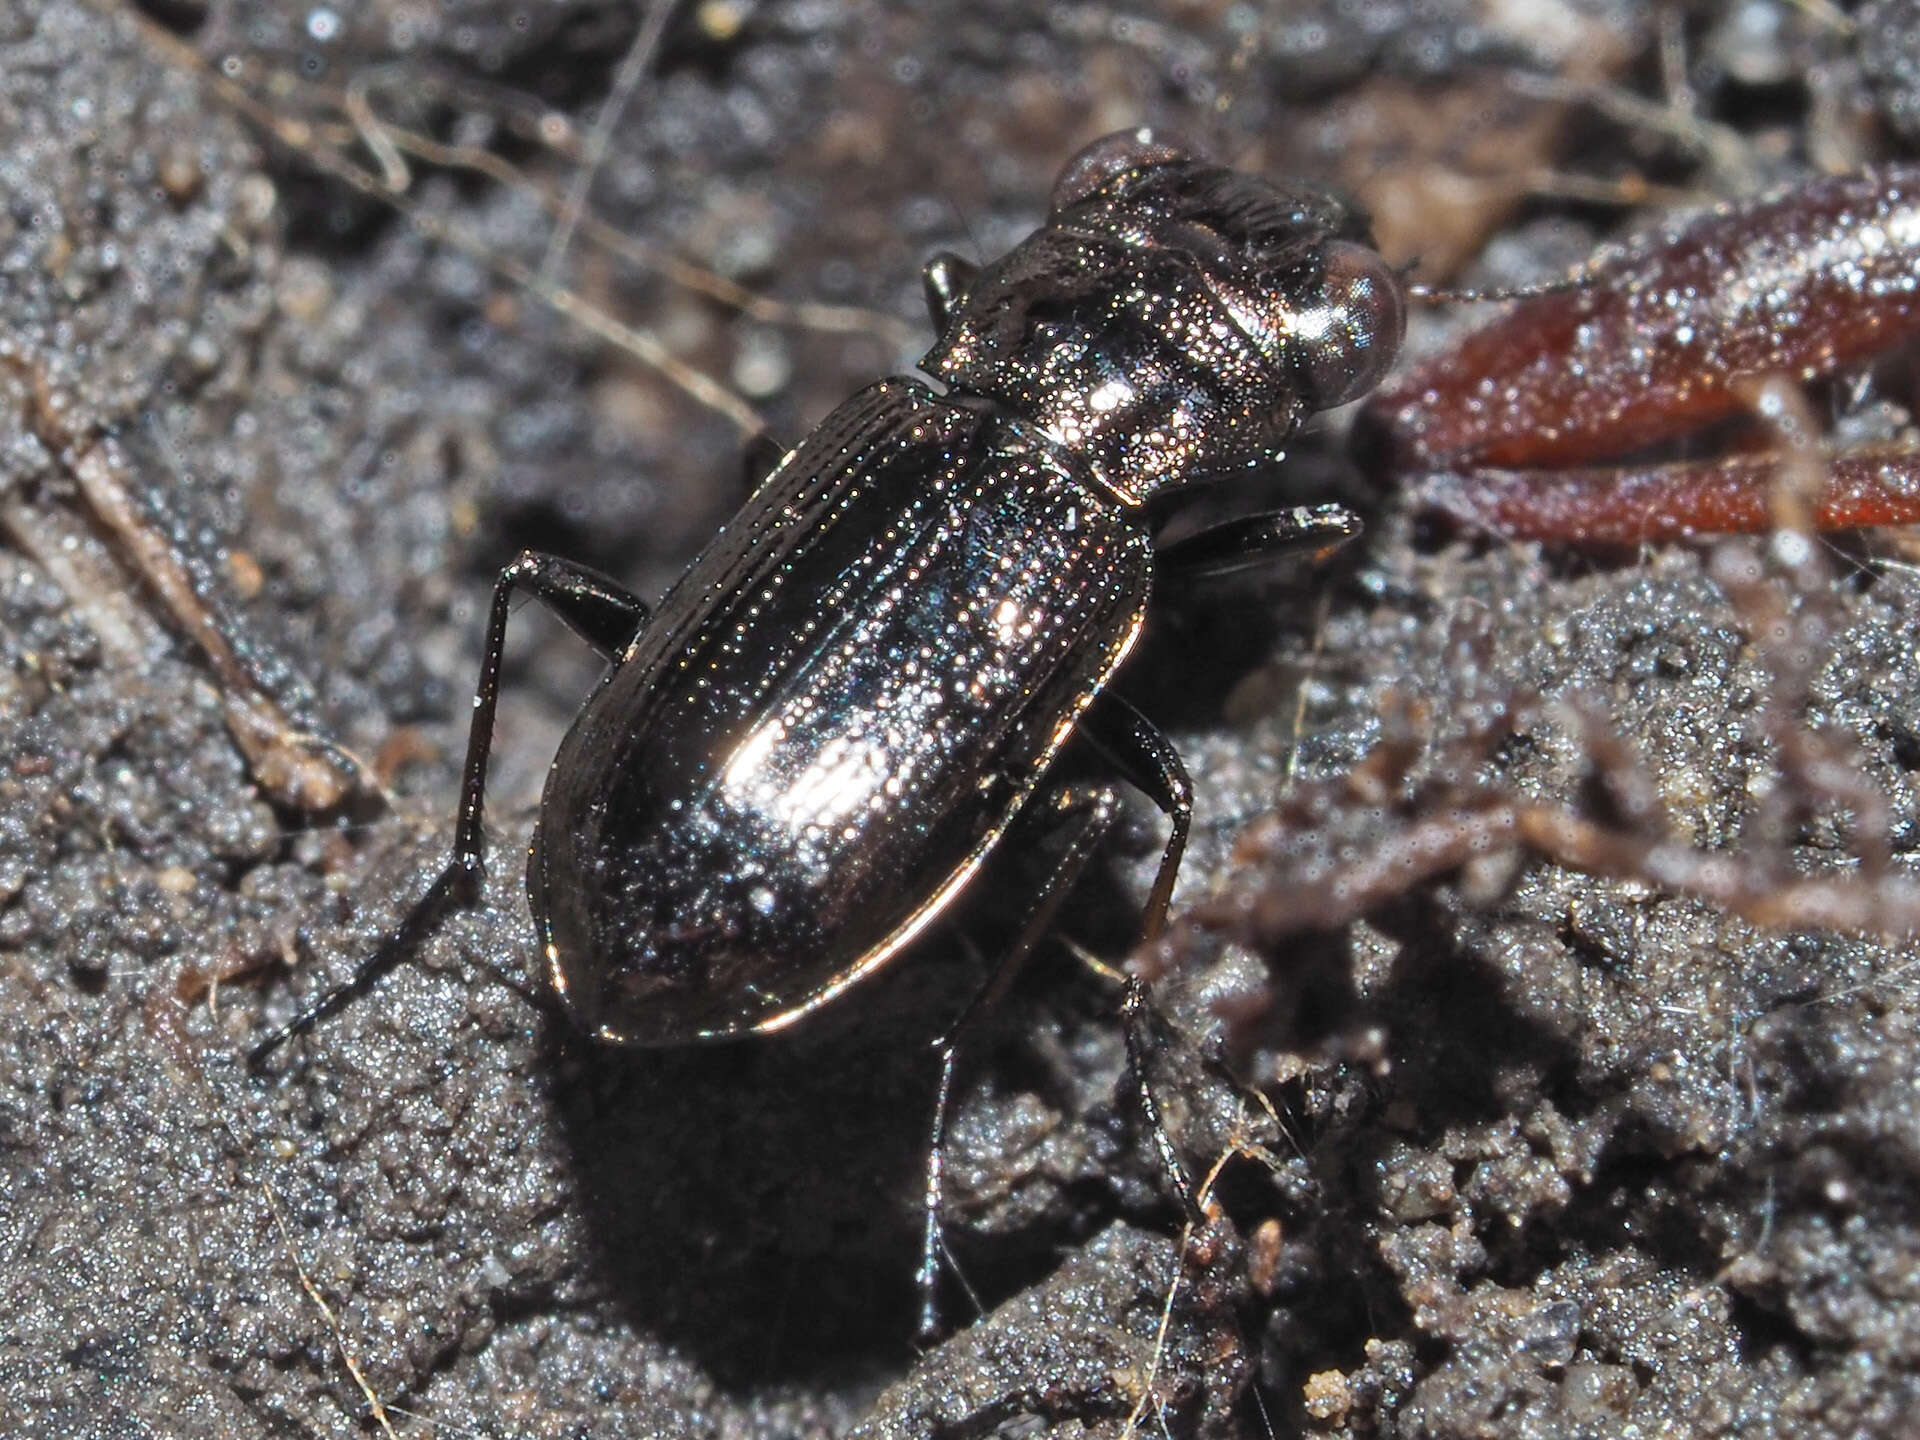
[253,131,1405,1320]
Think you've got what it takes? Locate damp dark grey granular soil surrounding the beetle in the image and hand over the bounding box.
[0,0,1920,1438]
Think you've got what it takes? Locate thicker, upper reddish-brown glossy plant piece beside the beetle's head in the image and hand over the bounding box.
[1365,165,1920,474]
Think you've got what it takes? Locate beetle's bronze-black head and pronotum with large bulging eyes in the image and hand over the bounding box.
[922,131,1405,501]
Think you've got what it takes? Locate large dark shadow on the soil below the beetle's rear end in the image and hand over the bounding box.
[551,902,1029,1388]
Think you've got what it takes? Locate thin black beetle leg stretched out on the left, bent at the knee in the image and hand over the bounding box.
[248,551,649,1066]
